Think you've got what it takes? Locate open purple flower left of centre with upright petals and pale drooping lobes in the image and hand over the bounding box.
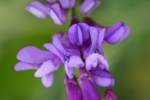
[44,33,84,79]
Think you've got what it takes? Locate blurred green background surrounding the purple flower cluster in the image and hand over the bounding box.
[0,0,150,100]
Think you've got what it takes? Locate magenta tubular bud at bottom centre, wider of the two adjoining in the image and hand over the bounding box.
[79,74,101,100]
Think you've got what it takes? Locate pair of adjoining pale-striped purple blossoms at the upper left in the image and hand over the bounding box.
[26,1,67,25]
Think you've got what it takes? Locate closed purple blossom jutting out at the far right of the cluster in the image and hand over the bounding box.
[105,22,130,44]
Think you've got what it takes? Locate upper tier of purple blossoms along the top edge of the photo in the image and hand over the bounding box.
[26,0,100,25]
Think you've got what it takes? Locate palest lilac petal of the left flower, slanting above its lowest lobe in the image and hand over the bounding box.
[35,60,58,77]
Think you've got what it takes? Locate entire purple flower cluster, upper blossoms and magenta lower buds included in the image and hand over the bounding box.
[15,0,130,100]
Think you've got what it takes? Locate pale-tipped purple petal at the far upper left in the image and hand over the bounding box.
[26,1,48,19]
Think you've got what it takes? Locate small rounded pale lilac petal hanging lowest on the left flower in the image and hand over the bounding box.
[42,73,54,88]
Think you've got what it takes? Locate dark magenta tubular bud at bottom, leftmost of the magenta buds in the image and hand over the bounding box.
[65,76,83,100]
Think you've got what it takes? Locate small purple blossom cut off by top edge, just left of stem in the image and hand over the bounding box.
[59,0,75,9]
